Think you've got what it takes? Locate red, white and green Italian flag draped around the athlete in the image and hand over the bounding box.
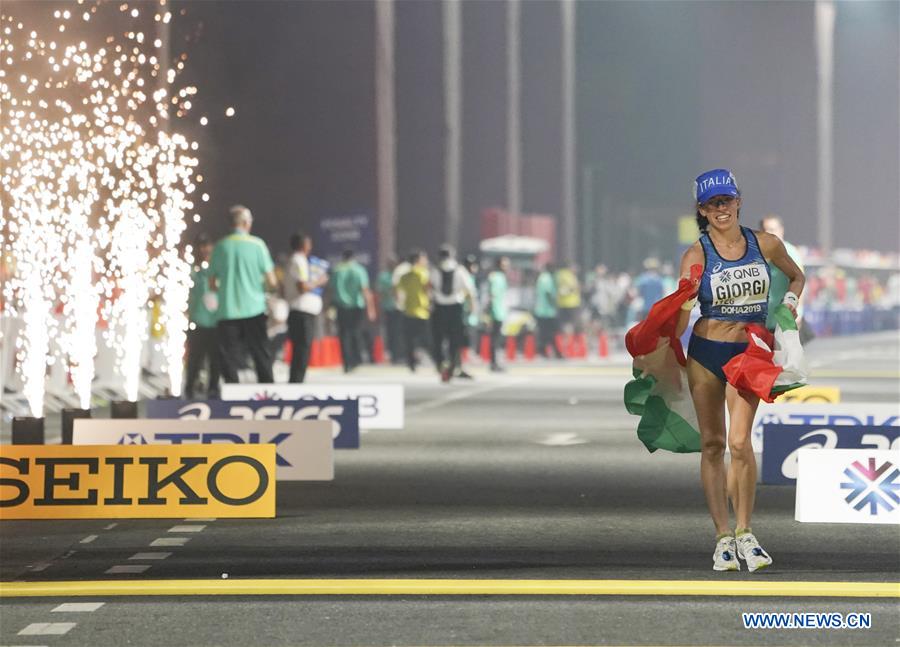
[625,265,807,453]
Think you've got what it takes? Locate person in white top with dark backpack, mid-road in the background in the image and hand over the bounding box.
[431,245,475,382]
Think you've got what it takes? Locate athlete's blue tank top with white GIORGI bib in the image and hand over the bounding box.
[697,227,771,324]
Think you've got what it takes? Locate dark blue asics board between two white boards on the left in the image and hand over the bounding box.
[147,400,359,449]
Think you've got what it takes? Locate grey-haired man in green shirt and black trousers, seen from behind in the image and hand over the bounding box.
[209,205,277,384]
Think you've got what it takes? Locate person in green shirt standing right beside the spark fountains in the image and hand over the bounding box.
[184,234,219,400]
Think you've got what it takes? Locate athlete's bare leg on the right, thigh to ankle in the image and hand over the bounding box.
[725,384,759,528]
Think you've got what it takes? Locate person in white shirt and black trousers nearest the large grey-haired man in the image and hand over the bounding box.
[284,232,328,382]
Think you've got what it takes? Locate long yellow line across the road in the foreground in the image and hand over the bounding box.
[0,579,900,598]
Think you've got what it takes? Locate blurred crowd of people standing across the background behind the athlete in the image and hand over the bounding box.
[178,206,900,397]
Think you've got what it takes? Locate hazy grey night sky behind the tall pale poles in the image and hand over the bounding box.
[167,0,900,269]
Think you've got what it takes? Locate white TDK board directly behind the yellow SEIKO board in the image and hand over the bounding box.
[72,418,335,481]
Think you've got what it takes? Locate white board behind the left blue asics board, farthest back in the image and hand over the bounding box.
[222,384,404,429]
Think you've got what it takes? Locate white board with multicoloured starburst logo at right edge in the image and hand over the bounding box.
[794,448,900,524]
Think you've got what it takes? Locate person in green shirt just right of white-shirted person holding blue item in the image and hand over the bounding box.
[331,249,375,373]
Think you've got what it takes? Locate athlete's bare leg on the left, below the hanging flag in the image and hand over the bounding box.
[687,357,731,534]
